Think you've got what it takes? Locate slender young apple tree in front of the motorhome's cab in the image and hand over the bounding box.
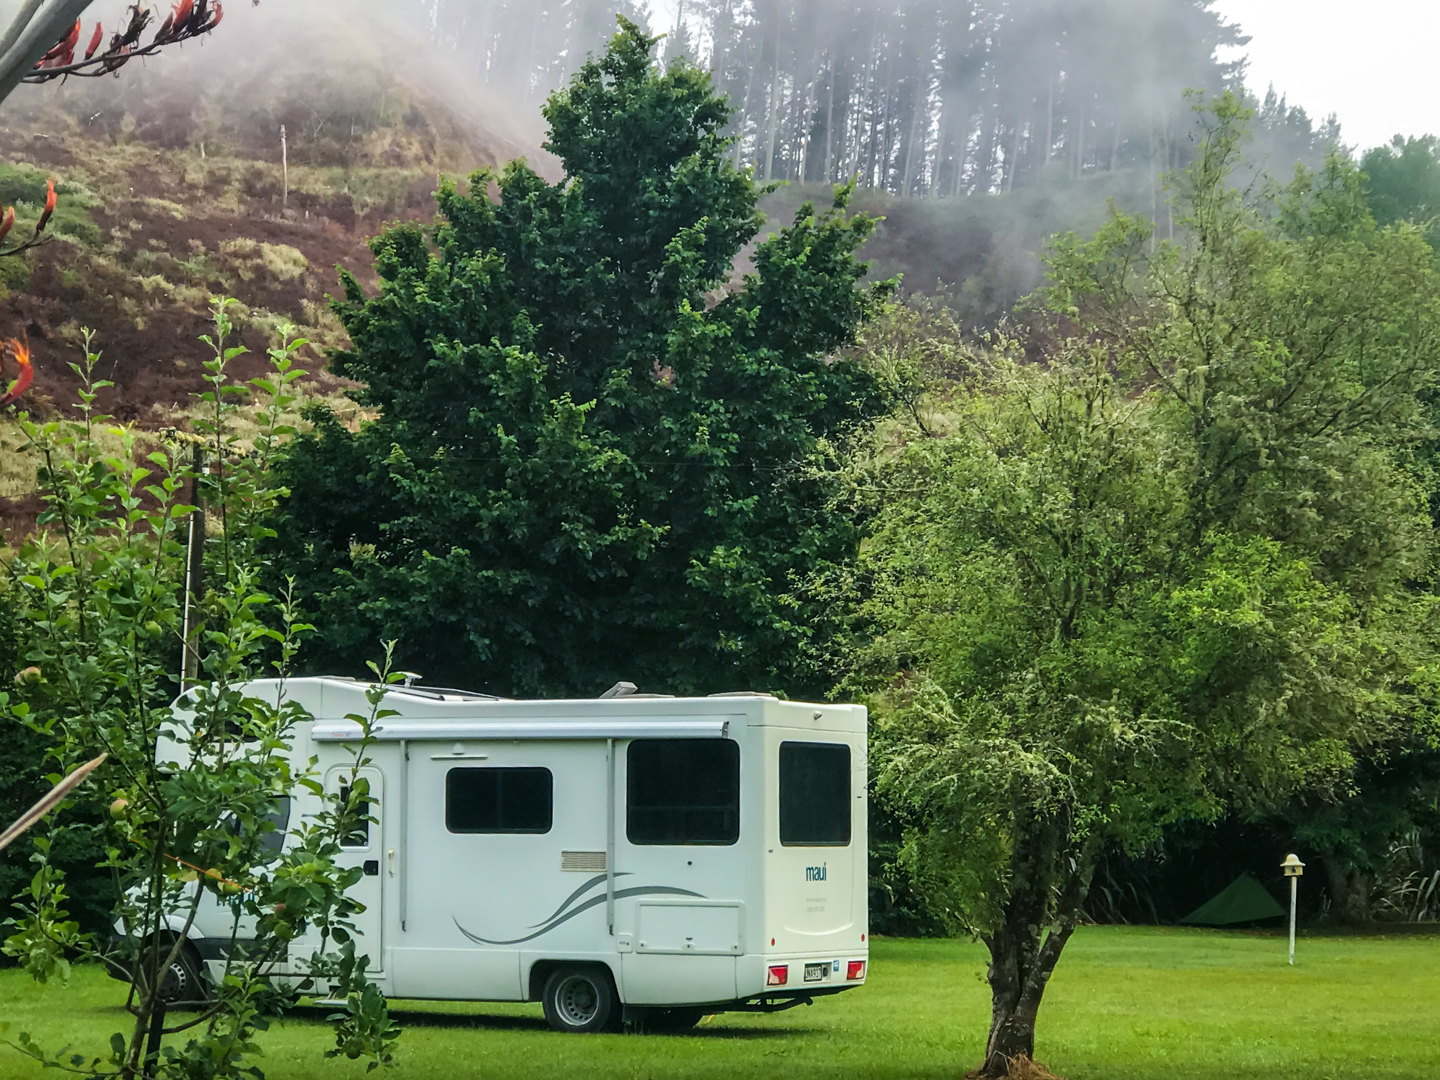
[0,302,397,1080]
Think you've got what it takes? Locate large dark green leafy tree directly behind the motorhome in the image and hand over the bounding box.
[264,20,880,693]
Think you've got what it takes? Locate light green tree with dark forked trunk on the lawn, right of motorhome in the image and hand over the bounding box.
[861,96,1440,1077]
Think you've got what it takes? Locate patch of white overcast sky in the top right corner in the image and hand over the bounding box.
[1215,0,1440,150]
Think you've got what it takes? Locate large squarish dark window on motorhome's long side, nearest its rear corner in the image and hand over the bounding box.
[625,739,740,845]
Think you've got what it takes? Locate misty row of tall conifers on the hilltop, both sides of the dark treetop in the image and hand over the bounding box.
[416,0,1339,197]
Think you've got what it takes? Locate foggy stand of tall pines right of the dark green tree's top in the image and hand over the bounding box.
[691,0,1238,196]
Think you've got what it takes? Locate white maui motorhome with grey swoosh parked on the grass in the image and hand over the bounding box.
[146,678,868,1031]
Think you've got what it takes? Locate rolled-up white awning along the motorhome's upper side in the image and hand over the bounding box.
[310,717,730,743]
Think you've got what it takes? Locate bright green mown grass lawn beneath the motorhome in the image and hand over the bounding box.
[0,927,1440,1080]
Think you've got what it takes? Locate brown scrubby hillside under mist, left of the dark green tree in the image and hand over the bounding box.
[0,9,543,423]
